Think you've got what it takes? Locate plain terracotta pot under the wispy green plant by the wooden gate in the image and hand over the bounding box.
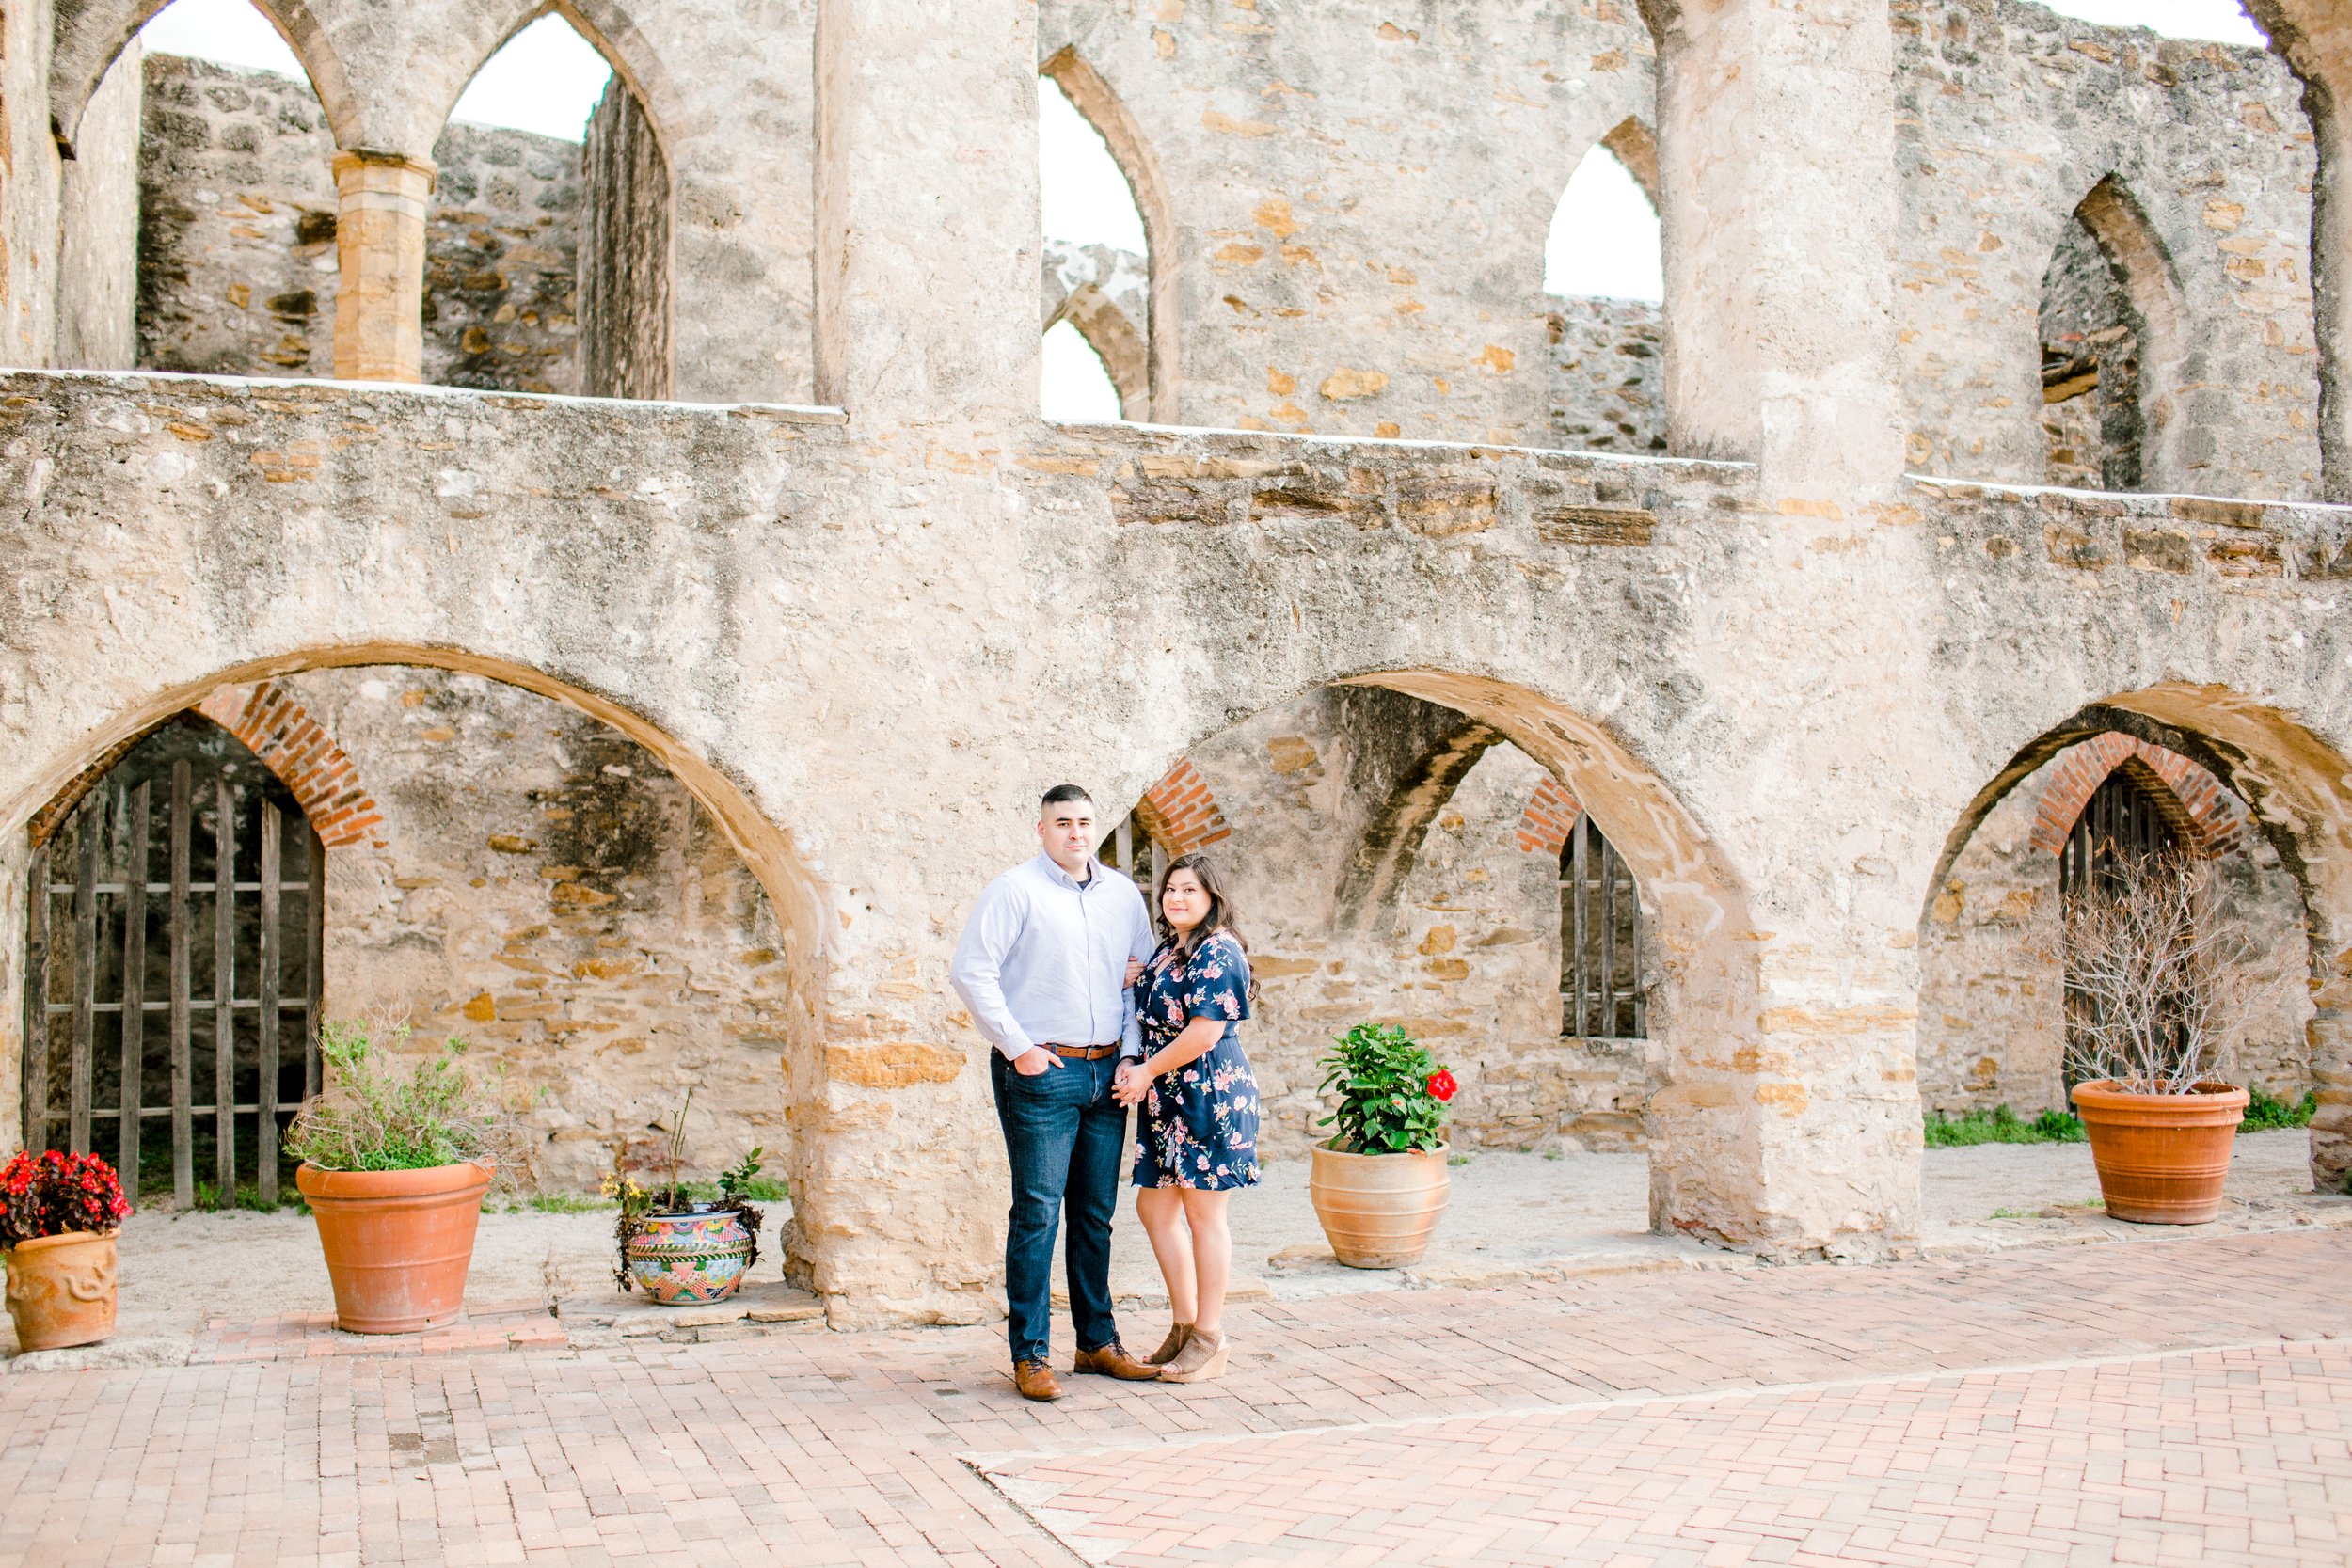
[294,1162,489,1333]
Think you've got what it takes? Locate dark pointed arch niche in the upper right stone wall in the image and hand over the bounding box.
[2040,176,2187,489]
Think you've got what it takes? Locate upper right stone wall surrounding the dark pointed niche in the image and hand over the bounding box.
[1896,0,2319,496]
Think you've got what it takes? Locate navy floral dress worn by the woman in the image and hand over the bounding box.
[1136,931,1259,1192]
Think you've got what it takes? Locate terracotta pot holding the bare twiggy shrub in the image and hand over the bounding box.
[2074,1084,2247,1225]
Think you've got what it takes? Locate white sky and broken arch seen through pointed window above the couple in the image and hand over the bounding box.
[1038,63,1167,419]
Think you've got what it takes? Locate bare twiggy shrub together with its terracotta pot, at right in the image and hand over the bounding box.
[2065,853,2261,1225]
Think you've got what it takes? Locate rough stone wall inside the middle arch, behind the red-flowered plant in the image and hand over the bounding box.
[1188,689,1649,1159]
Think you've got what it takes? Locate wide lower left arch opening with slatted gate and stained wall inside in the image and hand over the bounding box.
[26,649,823,1222]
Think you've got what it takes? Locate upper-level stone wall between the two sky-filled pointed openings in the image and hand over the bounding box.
[1038,0,1654,442]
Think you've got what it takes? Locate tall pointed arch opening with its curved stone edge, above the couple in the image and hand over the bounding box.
[1038,49,1176,423]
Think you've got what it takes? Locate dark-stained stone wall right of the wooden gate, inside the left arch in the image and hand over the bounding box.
[278,665,790,1192]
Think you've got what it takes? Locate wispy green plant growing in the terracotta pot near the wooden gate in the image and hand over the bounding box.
[285,1022,530,1178]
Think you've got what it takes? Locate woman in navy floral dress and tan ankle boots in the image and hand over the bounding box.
[1118,856,1259,1383]
